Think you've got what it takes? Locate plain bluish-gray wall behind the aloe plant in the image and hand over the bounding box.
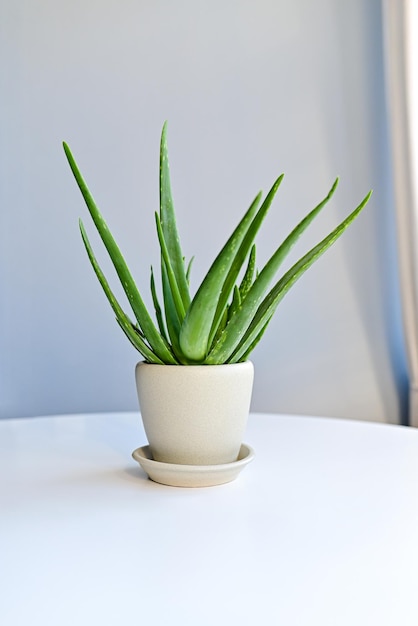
[0,0,405,422]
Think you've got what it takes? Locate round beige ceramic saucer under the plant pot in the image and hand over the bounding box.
[132,444,254,487]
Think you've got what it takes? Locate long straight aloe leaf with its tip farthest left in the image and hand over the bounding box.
[63,142,176,363]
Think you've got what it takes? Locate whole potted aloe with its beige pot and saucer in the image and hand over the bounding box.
[64,124,371,484]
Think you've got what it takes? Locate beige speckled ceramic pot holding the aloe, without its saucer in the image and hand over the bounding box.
[135,361,254,465]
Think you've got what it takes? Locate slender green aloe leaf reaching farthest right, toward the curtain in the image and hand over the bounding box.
[229,191,372,363]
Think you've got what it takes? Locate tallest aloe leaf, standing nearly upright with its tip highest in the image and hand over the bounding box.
[160,122,190,310]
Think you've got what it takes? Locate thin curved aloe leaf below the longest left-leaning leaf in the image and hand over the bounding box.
[80,220,163,364]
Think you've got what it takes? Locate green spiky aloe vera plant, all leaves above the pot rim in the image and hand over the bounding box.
[63,124,371,365]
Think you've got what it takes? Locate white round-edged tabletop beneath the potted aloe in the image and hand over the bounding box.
[0,413,418,626]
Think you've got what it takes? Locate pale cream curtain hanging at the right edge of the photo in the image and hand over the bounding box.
[383,0,418,427]
